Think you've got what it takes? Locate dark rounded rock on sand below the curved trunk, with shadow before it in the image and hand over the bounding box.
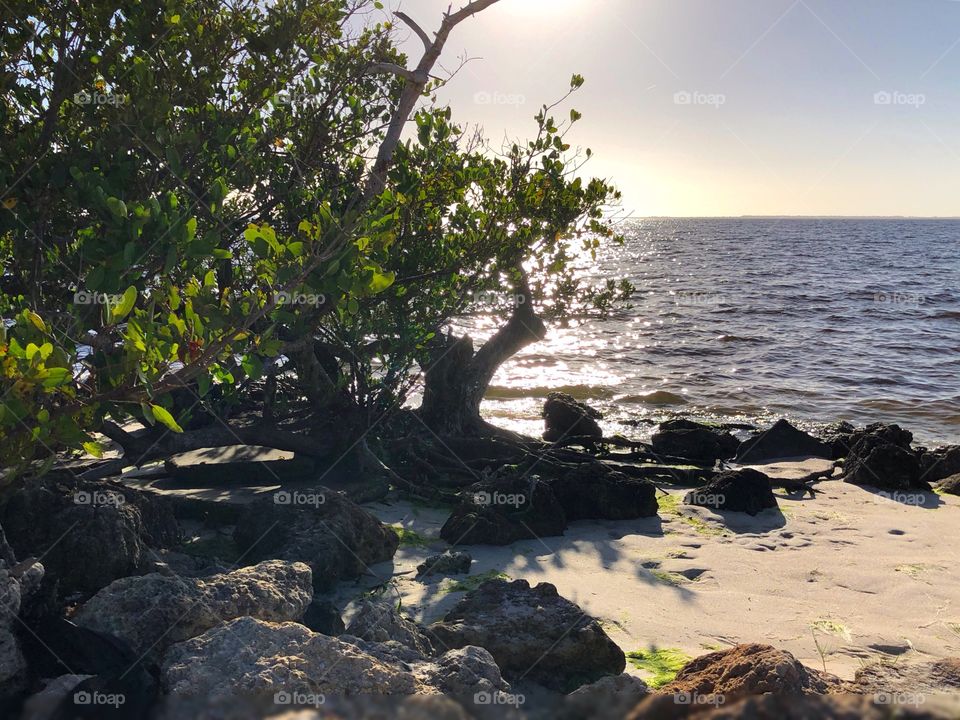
[440,475,567,545]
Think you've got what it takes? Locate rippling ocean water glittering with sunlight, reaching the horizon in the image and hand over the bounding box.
[476,218,960,446]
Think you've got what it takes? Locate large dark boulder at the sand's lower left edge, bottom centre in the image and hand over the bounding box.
[429,580,626,691]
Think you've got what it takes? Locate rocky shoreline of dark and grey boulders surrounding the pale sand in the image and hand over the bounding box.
[0,402,960,720]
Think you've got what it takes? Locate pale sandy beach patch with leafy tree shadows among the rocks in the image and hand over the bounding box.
[338,461,960,678]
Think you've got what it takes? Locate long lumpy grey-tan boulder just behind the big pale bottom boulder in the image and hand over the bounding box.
[74,560,313,658]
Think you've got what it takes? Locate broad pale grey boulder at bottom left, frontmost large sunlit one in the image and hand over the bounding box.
[161,617,419,704]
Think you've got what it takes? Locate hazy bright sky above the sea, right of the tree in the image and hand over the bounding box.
[385,0,960,216]
